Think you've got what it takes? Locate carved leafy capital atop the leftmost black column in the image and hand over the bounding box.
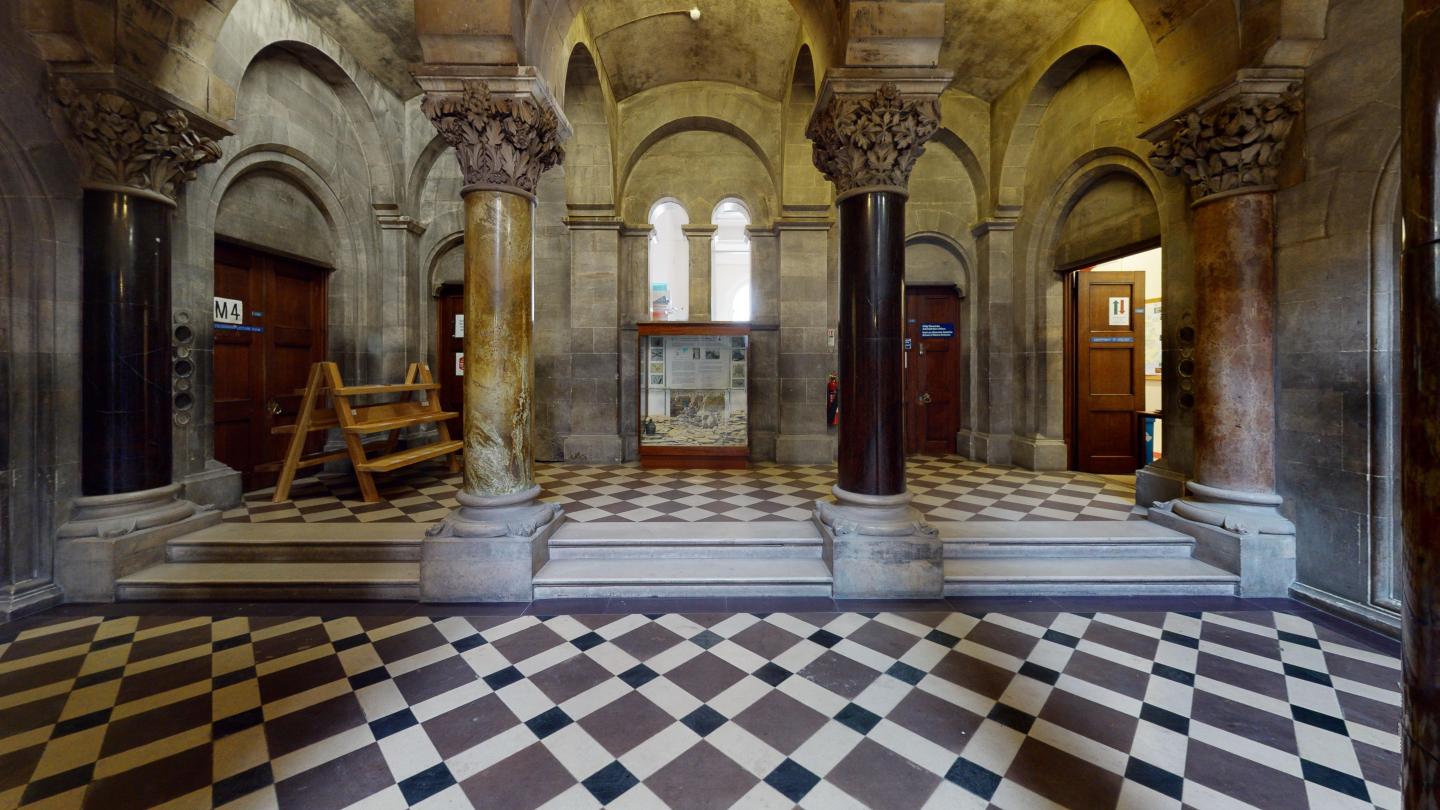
[55,79,220,203]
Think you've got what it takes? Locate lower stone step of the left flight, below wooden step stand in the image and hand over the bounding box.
[115,562,420,601]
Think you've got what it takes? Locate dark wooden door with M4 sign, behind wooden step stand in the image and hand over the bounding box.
[215,242,328,490]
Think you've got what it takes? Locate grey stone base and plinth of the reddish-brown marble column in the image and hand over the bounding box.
[1149,492,1295,597]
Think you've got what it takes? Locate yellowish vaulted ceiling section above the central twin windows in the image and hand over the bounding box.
[582,0,801,99]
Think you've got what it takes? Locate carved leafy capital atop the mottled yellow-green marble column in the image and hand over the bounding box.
[420,79,564,197]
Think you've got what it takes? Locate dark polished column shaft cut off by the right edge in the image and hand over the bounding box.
[1400,0,1440,809]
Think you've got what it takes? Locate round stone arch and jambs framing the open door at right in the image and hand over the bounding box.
[1015,147,1194,458]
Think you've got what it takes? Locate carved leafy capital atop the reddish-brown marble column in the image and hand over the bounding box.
[1146,76,1303,203]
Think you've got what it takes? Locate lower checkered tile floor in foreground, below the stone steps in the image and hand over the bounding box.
[0,610,1400,810]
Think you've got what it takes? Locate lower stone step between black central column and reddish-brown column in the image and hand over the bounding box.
[945,558,1240,597]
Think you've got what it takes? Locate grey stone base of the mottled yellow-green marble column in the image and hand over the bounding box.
[420,486,564,602]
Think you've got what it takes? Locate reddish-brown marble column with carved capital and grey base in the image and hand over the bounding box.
[1151,74,1300,597]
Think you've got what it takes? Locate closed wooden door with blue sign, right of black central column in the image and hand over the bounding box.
[904,287,960,454]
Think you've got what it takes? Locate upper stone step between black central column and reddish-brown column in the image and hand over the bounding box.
[933,520,1195,559]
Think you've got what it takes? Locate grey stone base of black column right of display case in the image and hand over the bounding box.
[815,486,945,600]
